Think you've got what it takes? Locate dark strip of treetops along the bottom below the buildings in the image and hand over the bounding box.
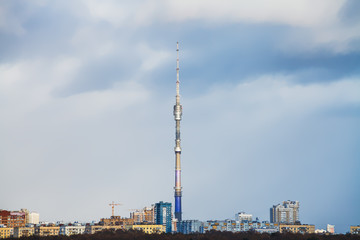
[8,230,360,240]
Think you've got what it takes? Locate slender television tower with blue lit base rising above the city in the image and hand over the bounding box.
[174,42,182,222]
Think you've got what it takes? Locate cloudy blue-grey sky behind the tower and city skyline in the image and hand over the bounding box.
[0,0,360,232]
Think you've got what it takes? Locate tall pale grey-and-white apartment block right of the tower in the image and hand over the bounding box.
[270,200,299,224]
